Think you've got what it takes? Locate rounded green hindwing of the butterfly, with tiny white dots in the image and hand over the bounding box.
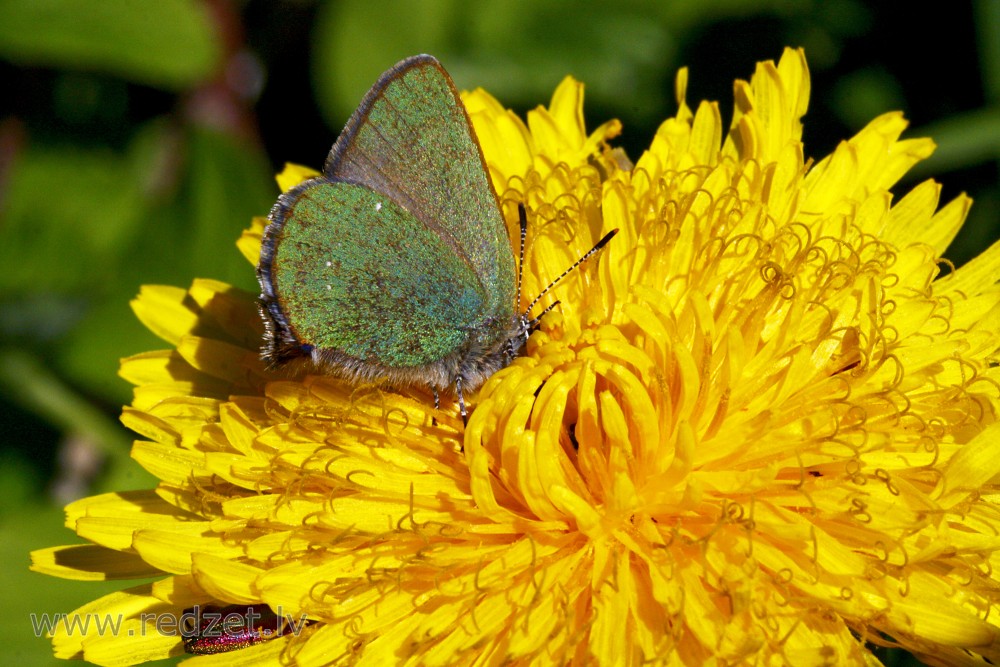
[273,181,488,368]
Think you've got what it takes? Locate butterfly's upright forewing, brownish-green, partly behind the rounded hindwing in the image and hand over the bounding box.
[324,55,516,320]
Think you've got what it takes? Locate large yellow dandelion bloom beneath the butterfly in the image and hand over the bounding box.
[34,45,1000,665]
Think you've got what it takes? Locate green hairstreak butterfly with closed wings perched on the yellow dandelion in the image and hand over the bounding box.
[257,55,610,418]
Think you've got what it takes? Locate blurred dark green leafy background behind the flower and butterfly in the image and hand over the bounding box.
[0,0,1000,665]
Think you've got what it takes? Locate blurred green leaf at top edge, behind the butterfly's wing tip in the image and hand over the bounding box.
[312,0,675,127]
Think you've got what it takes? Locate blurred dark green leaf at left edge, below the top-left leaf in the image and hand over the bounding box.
[0,124,167,399]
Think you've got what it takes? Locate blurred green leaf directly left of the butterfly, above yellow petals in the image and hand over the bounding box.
[53,127,278,402]
